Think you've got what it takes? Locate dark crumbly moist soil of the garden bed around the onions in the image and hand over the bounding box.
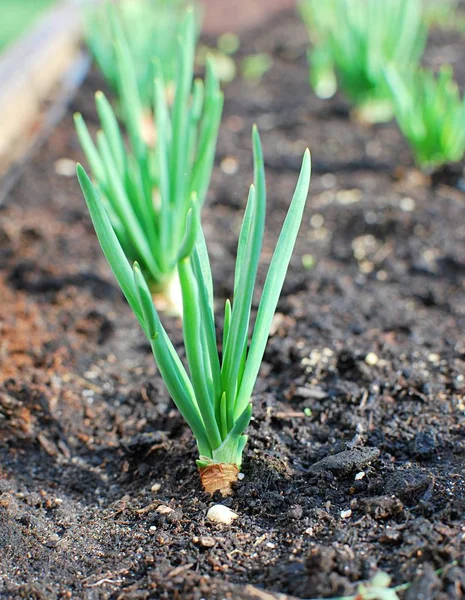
[0,9,465,600]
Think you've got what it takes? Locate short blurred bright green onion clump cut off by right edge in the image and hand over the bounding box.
[386,65,465,171]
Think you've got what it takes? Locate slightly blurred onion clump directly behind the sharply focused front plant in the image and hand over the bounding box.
[75,10,223,312]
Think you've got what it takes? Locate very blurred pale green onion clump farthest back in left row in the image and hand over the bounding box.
[86,0,192,108]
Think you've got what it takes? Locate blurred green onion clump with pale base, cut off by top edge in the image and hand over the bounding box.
[301,0,427,122]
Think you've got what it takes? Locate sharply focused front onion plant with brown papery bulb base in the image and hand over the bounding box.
[77,128,310,495]
